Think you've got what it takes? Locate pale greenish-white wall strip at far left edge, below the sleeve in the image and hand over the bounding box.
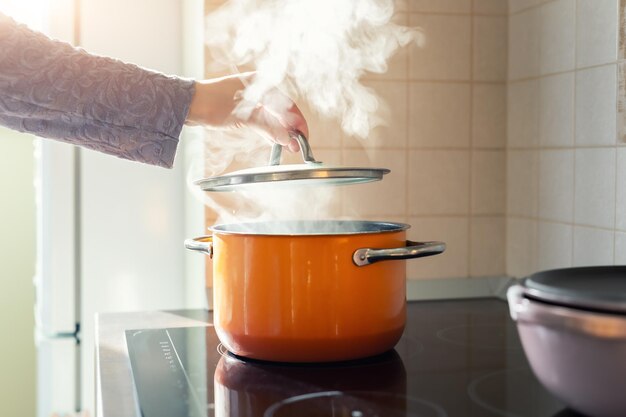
[0,128,36,416]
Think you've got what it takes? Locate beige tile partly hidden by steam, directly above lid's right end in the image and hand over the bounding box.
[344,81,408,149]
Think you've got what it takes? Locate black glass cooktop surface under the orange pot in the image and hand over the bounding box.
[126,299,580,417]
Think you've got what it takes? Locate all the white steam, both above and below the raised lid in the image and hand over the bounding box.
[188,0,422,228]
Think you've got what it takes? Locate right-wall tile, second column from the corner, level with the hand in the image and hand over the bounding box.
[539,72,574,147]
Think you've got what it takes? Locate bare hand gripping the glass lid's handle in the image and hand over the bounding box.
[185,73,309,152]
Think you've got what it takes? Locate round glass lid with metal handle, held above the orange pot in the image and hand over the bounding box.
[195,131,391,191]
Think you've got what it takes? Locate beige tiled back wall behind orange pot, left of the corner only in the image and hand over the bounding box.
[202,0,508,279]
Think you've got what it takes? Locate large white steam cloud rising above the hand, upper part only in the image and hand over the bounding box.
[206,0,422,138]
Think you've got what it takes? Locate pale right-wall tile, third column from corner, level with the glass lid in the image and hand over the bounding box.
[574,148,615,229]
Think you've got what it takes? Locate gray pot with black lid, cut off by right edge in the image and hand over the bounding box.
[507,266,626,417]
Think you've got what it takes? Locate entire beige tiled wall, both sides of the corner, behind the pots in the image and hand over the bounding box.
[201,0,626,279]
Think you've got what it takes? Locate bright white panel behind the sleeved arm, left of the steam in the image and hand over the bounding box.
[80,0,194,415]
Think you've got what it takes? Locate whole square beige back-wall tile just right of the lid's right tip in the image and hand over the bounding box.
[409,150,470,215]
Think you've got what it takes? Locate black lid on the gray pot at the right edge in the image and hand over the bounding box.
[524,266,626,314]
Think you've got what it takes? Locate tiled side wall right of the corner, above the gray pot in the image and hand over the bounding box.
[506,0,626,276]
